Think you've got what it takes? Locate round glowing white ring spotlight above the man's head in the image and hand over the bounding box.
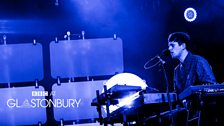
[184,7,197,22]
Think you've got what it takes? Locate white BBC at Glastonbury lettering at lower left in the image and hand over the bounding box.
[7,91,81,108]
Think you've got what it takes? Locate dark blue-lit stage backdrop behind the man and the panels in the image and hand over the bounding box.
[0,0,224,123]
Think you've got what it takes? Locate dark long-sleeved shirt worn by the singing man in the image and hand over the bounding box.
[174,52,216,93]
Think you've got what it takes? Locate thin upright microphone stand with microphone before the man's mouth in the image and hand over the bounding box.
[157,56,174,126]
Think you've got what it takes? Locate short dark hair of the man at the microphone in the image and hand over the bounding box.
[168,32,190,47]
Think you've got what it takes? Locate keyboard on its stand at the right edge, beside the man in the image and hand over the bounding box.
[179,84,224,126]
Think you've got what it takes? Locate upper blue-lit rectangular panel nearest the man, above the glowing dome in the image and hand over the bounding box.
[50,38,124,79]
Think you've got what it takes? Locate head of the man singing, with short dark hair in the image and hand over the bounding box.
[168,32,190,59]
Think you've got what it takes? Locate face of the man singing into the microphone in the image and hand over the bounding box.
[168,41,185,59]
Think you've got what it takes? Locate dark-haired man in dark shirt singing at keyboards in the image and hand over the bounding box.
[168,32,216,94]
